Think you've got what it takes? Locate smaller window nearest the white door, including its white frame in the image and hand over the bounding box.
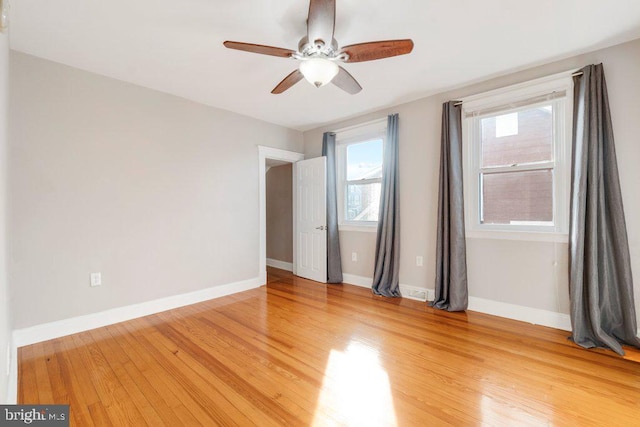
[336,120,387,229]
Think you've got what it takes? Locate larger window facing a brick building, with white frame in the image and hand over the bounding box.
[463,78,572,233]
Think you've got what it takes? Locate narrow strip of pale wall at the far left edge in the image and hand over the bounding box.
[0,28,11,402]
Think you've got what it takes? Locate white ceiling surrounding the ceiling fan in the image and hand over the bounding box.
[10,0,640,130]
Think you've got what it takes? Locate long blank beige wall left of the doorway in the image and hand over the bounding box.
[10,52,302,328]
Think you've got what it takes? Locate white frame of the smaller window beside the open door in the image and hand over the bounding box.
[335,118,387,232]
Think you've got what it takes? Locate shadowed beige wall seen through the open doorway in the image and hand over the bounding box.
[266,164,293,263]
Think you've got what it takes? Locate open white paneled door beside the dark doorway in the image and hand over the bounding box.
[293,157,327,283]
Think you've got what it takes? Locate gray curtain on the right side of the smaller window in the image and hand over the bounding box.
[371,114,401,297]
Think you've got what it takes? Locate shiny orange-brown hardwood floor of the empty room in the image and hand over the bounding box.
[18,269,640,426]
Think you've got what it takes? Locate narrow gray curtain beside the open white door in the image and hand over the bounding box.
[322,132,342,283]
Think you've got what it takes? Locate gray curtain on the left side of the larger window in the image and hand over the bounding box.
[431,101,468,311]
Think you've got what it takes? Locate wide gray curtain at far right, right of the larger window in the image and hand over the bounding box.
[569,64,640,355]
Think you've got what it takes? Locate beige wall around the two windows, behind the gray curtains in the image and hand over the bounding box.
[304,40,640,320]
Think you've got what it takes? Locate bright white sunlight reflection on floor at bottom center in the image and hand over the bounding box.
[313,341,397,426]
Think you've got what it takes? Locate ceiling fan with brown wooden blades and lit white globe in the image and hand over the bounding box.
[224,0,413,95]
